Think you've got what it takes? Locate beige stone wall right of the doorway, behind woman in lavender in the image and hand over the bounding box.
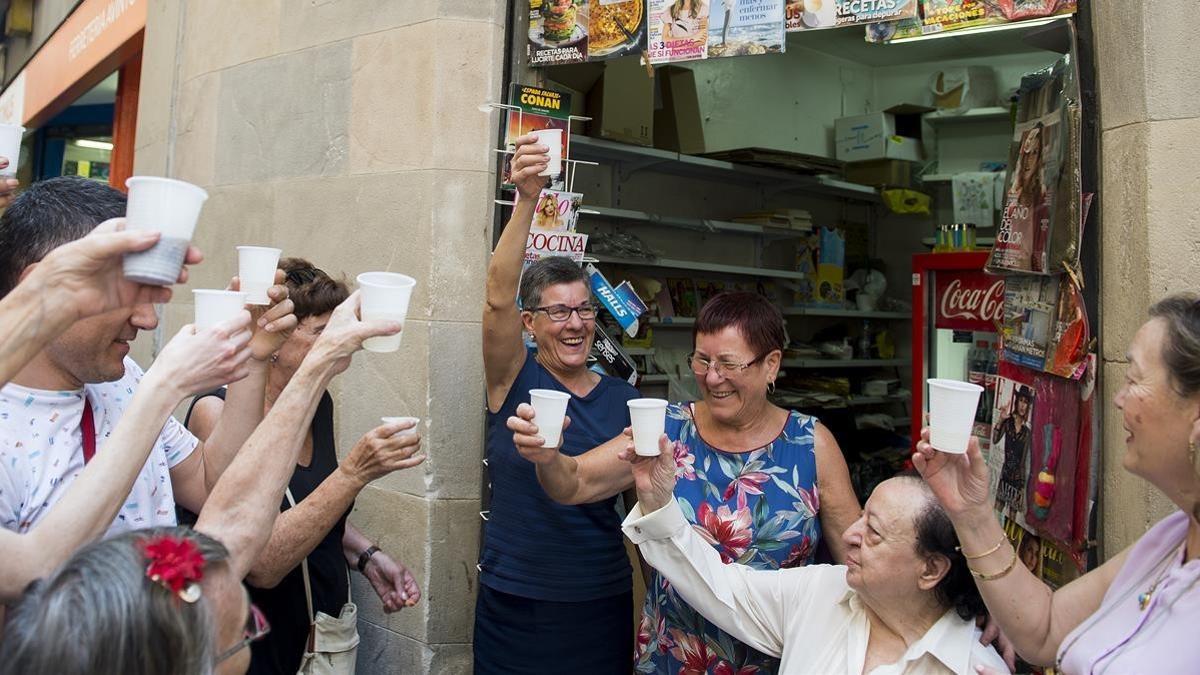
[1092,0,1200,557]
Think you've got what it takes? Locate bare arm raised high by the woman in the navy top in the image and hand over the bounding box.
[484,135,550,412]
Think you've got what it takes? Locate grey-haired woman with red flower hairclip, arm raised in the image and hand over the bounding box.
[0,293,401,675]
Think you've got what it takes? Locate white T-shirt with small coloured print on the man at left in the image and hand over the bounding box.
[0,358,198,537]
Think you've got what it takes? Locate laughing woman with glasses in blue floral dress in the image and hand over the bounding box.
[508,293,860,675]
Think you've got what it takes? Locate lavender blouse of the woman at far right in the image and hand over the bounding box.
[1058,512,1200,675]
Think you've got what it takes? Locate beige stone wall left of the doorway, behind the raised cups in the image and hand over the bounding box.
[136,0,505,675]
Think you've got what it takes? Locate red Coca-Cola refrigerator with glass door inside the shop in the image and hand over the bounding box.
[912,252,1004,449]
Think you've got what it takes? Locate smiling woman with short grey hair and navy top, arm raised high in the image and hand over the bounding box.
[474,136,638,675]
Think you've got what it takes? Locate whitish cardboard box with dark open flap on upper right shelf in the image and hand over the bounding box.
[834,103,932,162]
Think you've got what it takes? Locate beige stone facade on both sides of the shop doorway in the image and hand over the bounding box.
[5,0,1200,675]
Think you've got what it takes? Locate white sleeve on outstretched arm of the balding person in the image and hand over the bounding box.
[622,501,810,657]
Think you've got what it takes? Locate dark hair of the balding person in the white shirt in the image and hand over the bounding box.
[899,472,988,621]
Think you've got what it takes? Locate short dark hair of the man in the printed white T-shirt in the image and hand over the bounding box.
[0,175,125,298]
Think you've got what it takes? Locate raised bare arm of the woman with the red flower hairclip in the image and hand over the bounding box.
[196,292,401,579]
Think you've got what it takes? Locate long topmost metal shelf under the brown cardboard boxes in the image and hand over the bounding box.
[571,135,880,203]
